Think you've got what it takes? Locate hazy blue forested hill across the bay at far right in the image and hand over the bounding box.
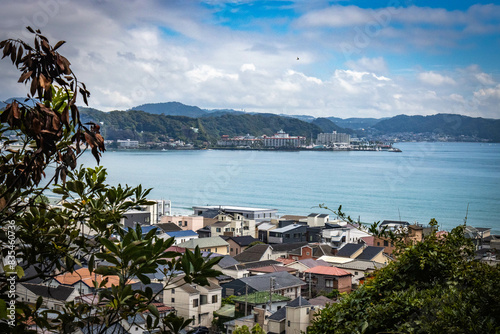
[373,114,500,142]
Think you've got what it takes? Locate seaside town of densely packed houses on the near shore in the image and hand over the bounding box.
[26,198,500,334]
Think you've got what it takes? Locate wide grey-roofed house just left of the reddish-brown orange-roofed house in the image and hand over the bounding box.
[221,271,305,298]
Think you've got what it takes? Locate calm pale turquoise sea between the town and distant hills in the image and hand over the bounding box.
[78,143,500,234]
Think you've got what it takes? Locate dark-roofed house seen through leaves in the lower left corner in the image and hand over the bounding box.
[16,283,79,311]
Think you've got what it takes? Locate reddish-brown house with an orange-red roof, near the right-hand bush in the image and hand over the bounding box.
[304,266,352,292]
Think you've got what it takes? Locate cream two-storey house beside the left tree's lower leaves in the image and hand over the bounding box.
[163,275,222,327]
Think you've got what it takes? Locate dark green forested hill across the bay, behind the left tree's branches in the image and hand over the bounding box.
[80,108,323,143]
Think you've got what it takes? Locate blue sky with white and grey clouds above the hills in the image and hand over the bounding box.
[0,0,500,118]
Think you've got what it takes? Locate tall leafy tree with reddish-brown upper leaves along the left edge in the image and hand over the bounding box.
[0,27,219,333]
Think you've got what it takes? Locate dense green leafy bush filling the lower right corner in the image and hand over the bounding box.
[310,220,500,333]
